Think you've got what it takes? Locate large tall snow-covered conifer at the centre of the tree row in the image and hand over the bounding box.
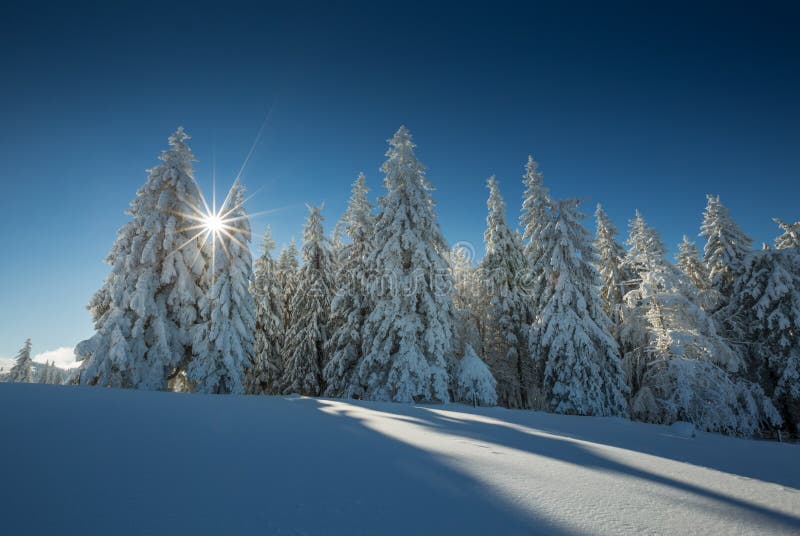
[356,127,455,402]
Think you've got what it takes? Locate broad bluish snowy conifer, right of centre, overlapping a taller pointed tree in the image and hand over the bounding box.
[531,199,627,415]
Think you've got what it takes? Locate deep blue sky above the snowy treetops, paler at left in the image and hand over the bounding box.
[0,1,800,356]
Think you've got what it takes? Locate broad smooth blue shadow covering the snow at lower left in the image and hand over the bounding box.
[0,385,570,536]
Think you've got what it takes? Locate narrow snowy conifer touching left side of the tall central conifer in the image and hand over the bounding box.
[323,173,375,397]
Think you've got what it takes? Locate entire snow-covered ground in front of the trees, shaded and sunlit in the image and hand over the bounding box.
[0,384,800,535]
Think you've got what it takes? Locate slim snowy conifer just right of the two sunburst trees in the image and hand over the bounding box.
[253,227,284,394]
